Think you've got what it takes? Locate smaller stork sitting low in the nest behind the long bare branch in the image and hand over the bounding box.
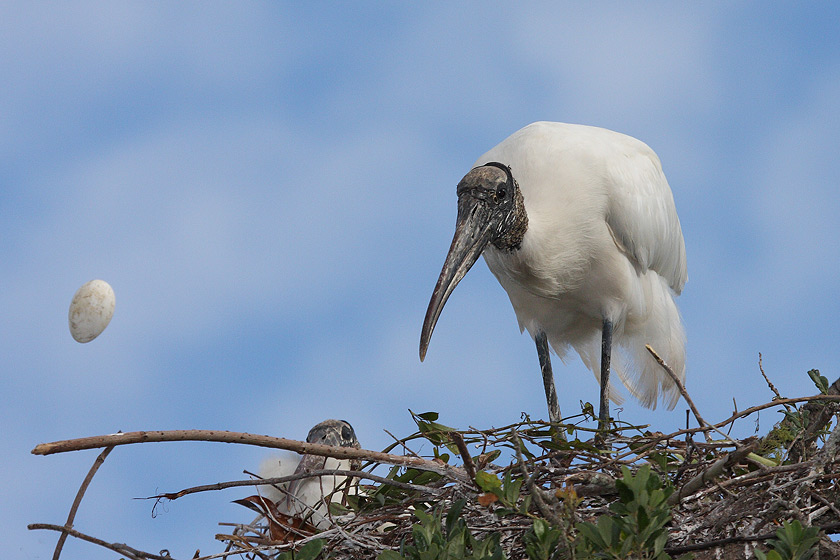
[259,420,361,529]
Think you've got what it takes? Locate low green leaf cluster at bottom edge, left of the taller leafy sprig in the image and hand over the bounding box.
[377,500,506,560]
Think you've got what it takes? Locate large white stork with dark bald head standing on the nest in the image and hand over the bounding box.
[420,122,688,429]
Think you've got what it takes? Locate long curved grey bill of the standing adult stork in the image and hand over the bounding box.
[420,195,492,362]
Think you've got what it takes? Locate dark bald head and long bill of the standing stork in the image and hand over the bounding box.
[420,161,528,361]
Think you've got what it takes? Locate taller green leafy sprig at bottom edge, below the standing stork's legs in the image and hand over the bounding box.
[577,465,673,560]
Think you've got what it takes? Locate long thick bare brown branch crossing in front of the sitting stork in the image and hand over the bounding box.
[32,430,470,482]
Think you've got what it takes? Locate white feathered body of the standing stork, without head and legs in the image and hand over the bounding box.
[475,122,688,408]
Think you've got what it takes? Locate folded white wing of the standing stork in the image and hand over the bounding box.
[607,142,688,294]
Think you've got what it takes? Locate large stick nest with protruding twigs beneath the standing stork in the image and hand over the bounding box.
[29,371,840,560]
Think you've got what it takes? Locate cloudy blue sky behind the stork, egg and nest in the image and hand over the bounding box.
[0,2,840,559]
